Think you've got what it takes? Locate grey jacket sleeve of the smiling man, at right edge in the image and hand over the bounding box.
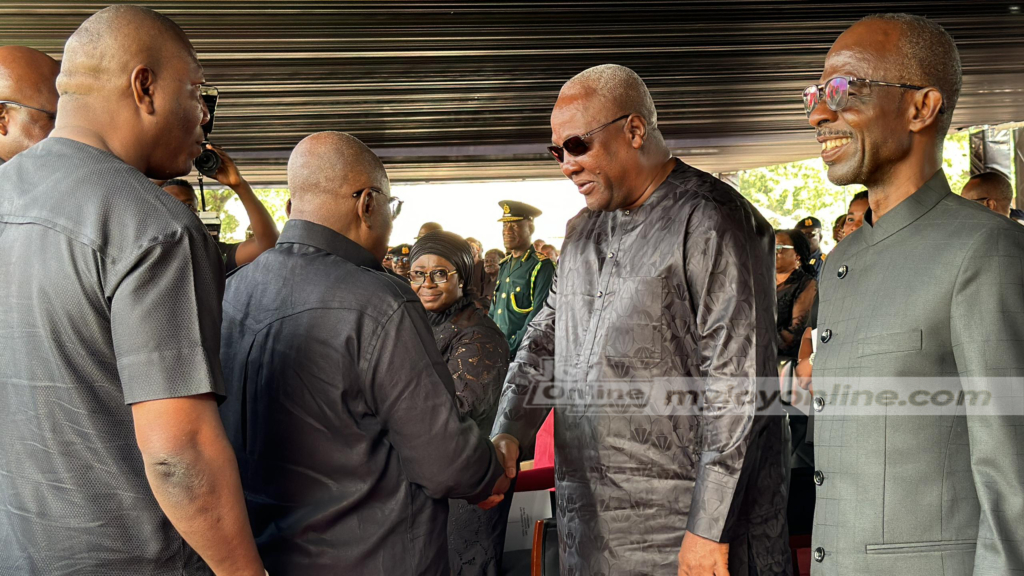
[950,227,1024,576]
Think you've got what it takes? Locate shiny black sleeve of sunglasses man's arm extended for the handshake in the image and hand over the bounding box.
[490,266,558,454]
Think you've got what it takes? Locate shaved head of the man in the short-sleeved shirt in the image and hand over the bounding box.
[54,4,209,179]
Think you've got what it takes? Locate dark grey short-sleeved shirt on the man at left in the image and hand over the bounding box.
[0,138,224,576]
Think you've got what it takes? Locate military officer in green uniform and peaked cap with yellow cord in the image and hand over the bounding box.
[489,200,555,358]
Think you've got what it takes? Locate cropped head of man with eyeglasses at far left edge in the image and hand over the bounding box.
[0,46,60,165]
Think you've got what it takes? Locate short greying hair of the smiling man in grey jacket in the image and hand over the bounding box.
[860,13,963,136]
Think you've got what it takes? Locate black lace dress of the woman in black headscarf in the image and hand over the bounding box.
[427,297,512,576]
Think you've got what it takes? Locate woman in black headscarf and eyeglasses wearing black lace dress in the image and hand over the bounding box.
[410,232,512,576]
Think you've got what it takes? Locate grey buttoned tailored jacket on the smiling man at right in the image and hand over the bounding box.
[811,170,1024,576]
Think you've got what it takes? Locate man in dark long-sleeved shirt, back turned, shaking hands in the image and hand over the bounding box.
[221,132,510,576]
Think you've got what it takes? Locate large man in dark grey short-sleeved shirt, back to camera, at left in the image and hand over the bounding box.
[0,6,264,576]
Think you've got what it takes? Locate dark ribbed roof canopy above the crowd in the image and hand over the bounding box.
[0,0,1024,184]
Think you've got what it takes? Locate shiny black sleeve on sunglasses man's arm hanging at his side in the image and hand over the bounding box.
[684,203,776,541]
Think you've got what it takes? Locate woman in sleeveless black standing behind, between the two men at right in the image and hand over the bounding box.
[775,230,818,361]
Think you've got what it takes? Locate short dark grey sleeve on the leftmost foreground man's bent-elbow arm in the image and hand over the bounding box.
[109,229,224,404]
